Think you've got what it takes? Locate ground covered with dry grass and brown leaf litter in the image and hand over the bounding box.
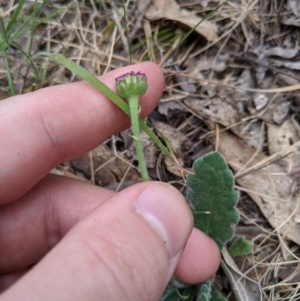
[0,0,300,300]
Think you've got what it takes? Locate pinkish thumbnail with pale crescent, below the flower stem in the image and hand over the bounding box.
[136,184,193,257]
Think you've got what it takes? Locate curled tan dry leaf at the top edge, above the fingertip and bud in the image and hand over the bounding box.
[139,0,218,42]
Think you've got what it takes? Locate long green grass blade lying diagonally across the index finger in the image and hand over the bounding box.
[33,53,172,159]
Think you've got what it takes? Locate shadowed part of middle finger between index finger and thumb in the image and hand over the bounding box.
[0,175,115,274]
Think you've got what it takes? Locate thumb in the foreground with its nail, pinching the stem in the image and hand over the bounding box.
[2,182,193,301]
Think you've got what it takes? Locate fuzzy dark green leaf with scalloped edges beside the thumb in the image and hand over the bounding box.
[186,152,239,249]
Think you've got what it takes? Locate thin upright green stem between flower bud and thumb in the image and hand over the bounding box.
[128,96,149,181]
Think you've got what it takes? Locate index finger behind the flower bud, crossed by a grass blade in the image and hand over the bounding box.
[0,62,164,204]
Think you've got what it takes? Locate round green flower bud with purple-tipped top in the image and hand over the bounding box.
[115,71,148,99]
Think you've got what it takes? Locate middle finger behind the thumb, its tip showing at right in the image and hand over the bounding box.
[0,175,220,287]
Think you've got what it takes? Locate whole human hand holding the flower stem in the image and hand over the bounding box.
[0,62,220,301]
